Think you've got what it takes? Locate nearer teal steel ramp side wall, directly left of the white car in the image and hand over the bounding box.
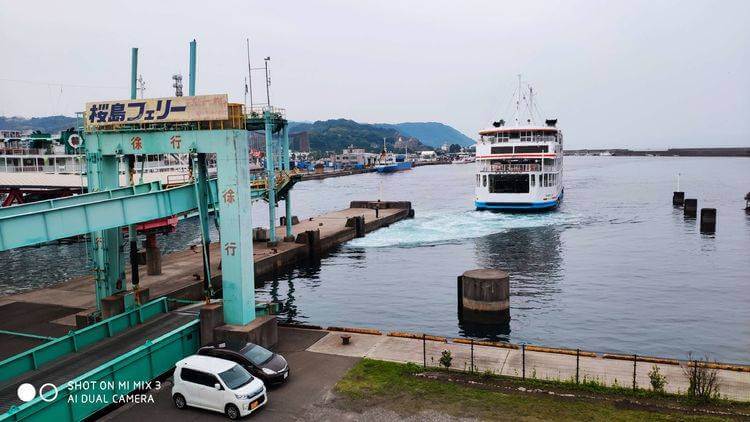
[0,320,200,422]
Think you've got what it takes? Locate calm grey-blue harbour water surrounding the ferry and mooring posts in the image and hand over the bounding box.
[0,157,750,363]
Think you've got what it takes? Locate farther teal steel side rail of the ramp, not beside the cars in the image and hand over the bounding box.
[0,297,169,382]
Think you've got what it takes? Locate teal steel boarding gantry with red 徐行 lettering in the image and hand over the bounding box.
[0,41,299,325]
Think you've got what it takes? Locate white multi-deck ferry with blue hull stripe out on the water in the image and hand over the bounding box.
[474,78,564,211]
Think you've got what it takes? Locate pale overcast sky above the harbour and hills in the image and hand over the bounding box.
[0,0,750,148]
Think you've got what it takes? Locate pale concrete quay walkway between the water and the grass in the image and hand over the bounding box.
[300,325,750,402]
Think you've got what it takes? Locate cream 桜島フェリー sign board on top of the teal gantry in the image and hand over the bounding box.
[84,94,229,128]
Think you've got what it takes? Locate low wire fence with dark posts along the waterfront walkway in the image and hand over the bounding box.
[388,333,750,401]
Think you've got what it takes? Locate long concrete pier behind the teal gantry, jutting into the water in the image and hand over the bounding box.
[0,201,413,326]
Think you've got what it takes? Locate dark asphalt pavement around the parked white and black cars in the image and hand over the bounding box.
[102,328,359,422]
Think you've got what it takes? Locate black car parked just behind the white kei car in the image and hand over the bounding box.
[198,342,289,385]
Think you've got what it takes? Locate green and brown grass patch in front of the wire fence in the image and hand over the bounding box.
[336,359,747,421]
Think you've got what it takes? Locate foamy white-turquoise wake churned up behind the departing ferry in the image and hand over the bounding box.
[347,210,581,248]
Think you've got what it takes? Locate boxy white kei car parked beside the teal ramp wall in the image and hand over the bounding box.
[172,355,268,419]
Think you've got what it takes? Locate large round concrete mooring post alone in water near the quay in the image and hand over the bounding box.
[457,269,510,324]
